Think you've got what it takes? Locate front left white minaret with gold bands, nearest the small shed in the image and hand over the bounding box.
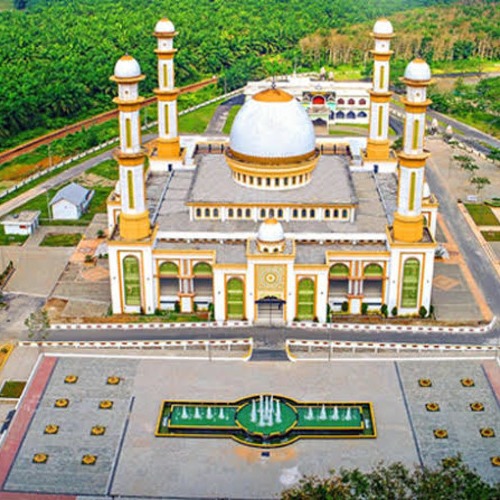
[111,55,151,240]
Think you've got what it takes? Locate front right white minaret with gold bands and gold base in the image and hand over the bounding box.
[394,59,431,243]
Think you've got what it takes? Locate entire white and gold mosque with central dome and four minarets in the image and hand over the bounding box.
[107,19,438,324]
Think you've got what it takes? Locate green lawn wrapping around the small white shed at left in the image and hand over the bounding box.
[10,185,113,226]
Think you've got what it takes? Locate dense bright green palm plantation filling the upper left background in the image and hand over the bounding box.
[0,0,460,143]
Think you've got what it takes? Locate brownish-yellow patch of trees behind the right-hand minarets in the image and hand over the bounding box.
[300,0,500,65]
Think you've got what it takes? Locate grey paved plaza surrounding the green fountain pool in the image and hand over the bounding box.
[0,356,500,498]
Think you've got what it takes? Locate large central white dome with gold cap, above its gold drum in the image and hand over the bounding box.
[229,89,316,158]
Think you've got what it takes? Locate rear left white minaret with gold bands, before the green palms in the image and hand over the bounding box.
[154,18,180,162]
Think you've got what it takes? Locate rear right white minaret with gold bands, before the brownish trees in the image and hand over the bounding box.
[366,19,394,161]
